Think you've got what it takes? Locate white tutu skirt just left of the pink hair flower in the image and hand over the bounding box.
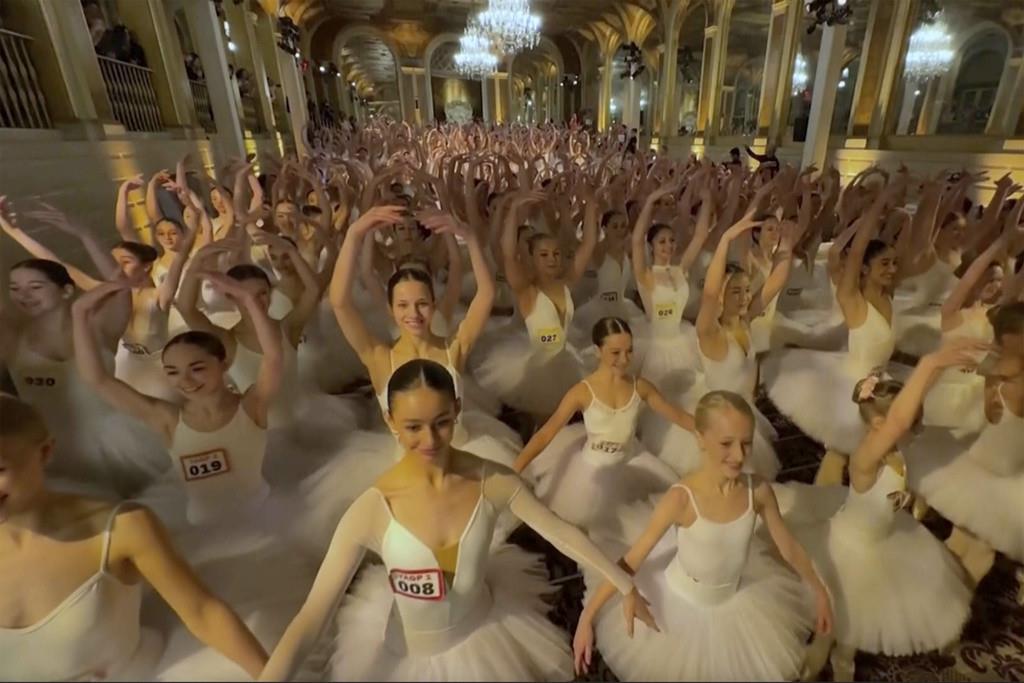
[761,349,865,454]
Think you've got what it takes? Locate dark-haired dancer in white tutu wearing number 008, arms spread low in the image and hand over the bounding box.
[260,359,653,681]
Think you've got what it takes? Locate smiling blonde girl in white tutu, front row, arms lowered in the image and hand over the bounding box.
[573,391,833,681]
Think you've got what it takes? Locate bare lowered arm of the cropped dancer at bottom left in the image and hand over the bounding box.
[111,508,267,678]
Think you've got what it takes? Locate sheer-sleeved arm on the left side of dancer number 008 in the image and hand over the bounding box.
[259,490,381,681]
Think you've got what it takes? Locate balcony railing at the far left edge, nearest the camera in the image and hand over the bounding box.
[0,29,51,128]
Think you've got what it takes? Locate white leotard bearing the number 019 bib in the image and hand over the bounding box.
[168,401,270,525]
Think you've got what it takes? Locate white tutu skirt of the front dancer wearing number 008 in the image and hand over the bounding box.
[330,546,572,681]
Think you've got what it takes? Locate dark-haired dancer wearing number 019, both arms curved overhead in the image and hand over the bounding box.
[72,271,312,680]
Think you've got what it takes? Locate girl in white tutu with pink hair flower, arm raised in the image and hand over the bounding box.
[794,341,981,681]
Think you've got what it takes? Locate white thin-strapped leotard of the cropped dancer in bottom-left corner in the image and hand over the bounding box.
[0,504,142,681]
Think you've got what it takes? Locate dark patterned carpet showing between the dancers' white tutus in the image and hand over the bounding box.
[503,399,1024,681]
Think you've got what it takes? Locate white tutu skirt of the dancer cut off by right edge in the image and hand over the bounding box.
[906,426,1024,562]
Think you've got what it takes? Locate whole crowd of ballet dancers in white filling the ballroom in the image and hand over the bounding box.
[0,120,1024,681]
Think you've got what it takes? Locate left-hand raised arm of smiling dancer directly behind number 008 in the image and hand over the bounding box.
[330,206,402,360]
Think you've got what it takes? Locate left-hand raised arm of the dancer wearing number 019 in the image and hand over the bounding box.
[71,280,177,438]
